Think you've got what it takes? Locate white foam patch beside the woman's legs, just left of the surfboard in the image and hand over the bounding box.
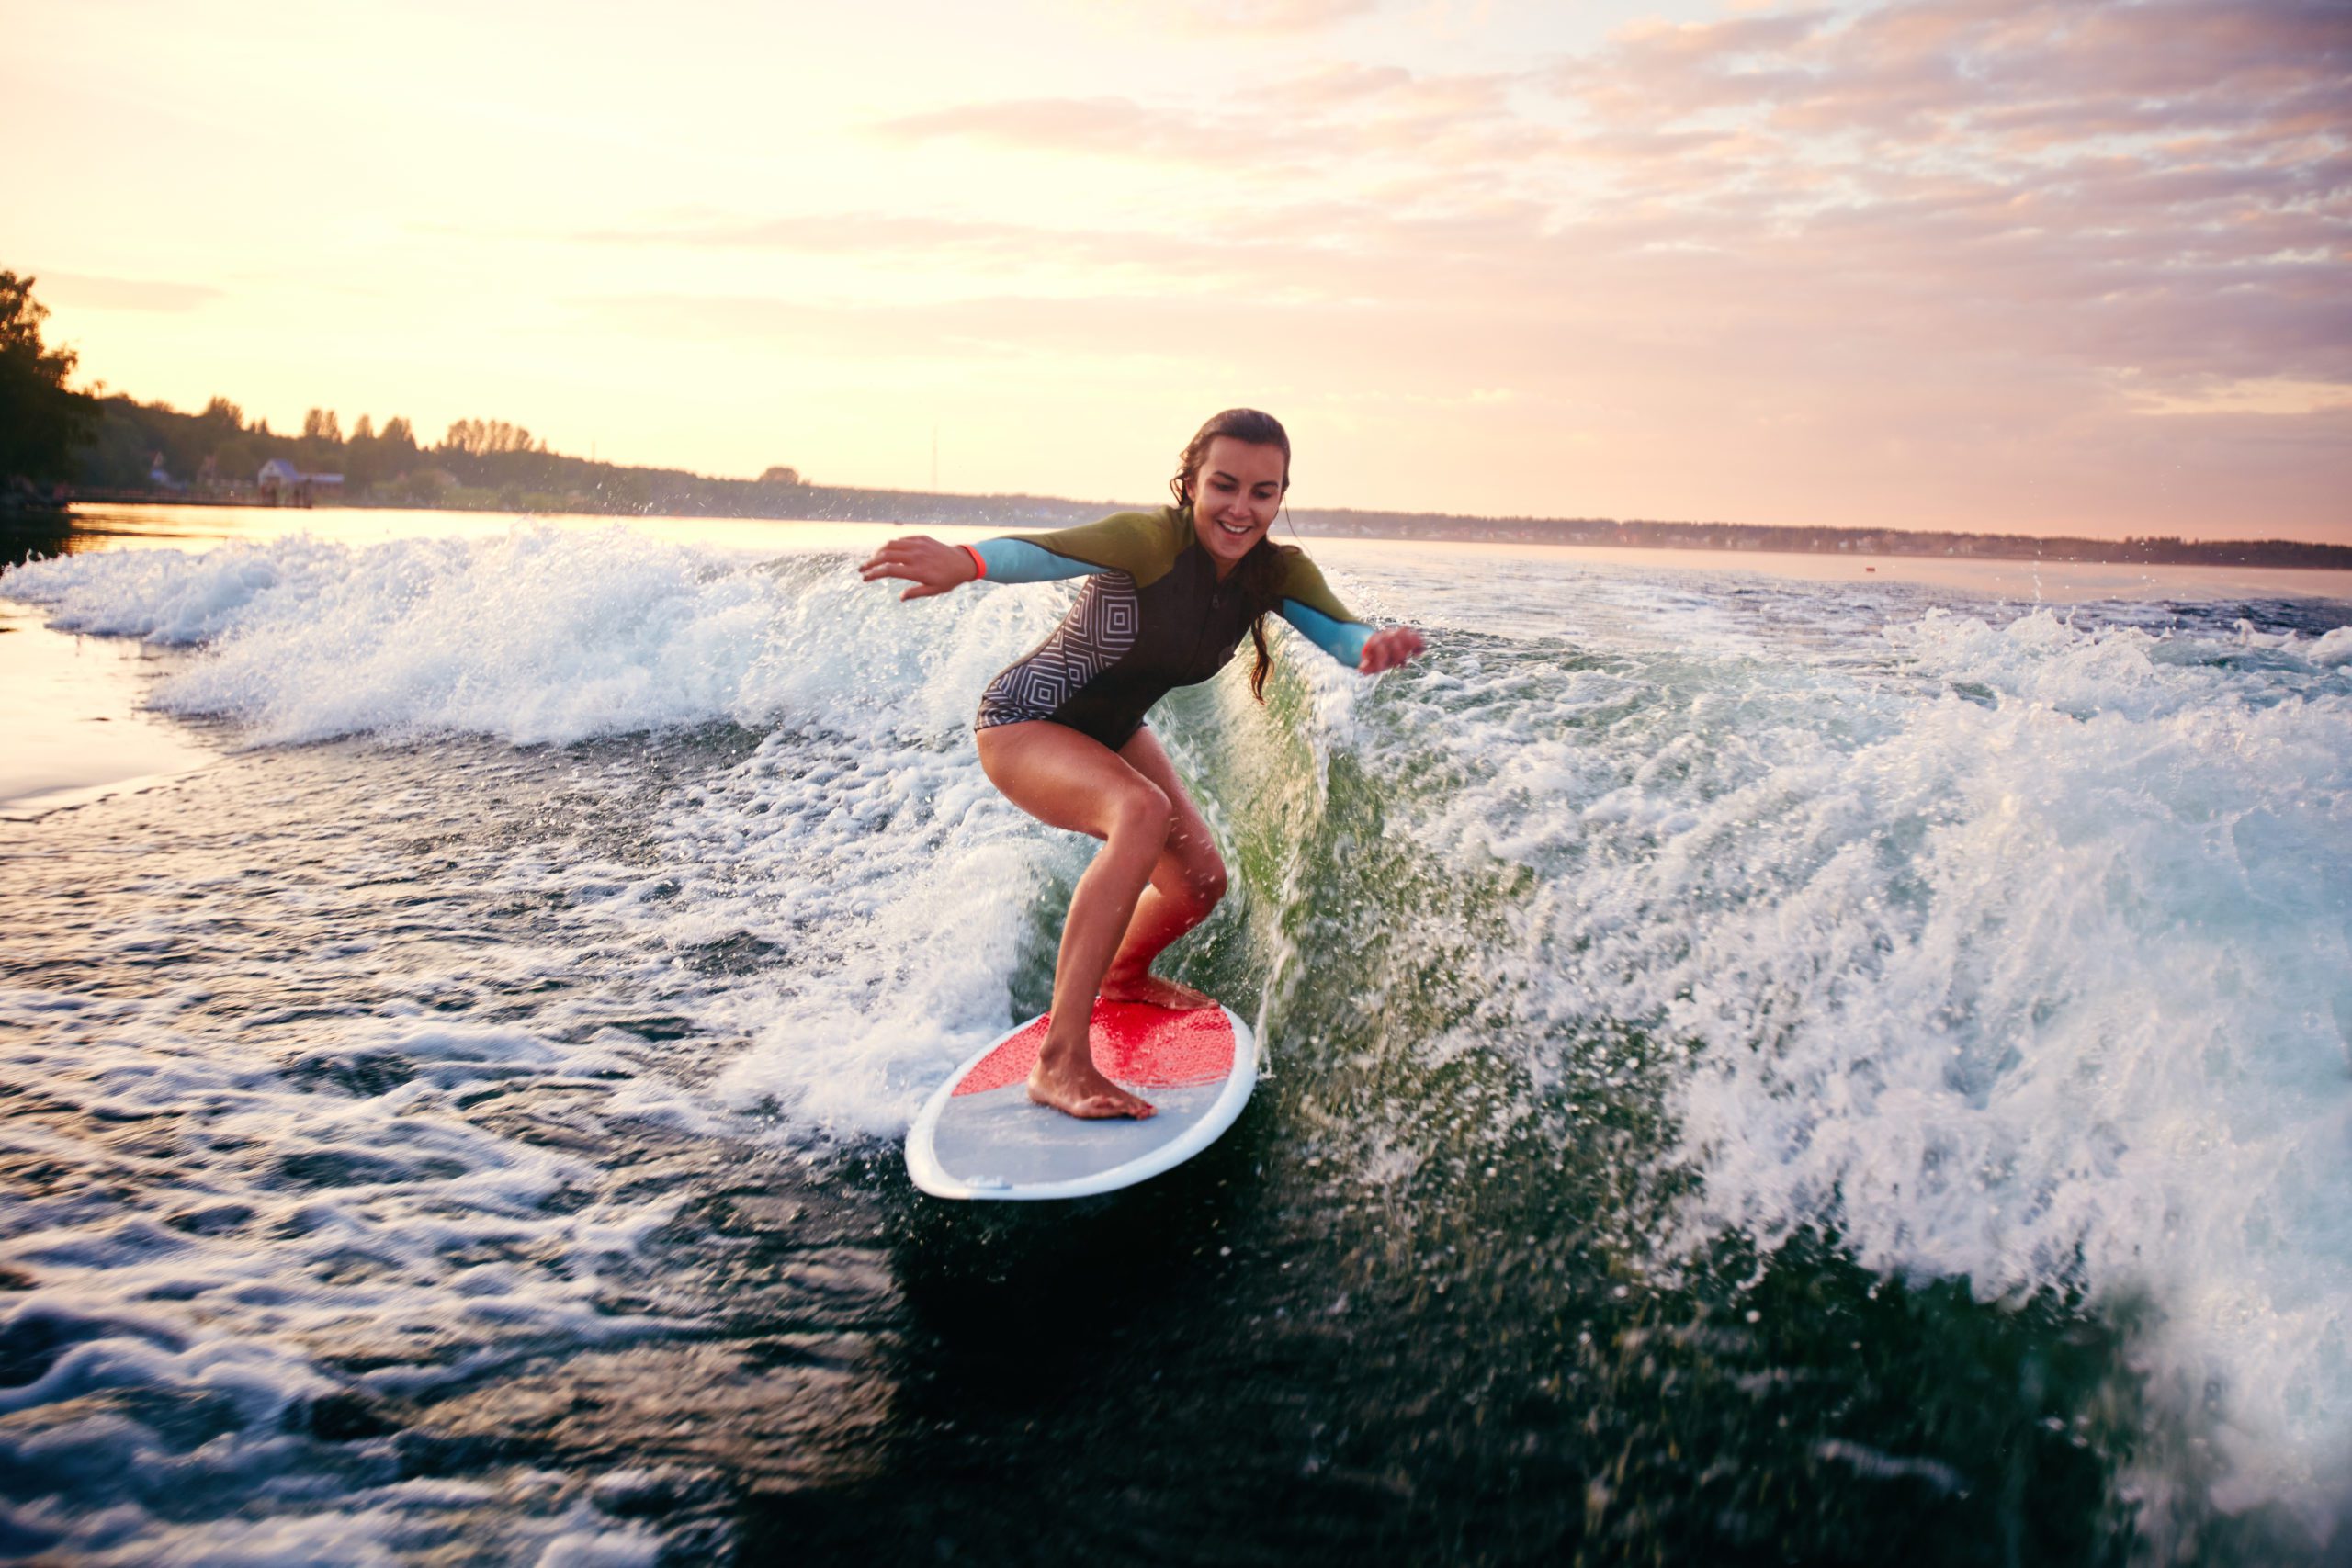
[609,736,1077,1135]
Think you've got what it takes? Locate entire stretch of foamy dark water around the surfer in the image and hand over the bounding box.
[0,510,2352,1565]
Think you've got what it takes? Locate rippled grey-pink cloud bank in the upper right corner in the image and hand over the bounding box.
[1547,0,2352,395]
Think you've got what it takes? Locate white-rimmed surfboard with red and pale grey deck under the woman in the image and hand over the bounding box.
[906,999,1259,1199]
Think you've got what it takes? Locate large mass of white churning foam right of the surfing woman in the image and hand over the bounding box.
[1397,614,2352,1506]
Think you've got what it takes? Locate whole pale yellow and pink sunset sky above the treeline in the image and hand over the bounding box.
[0,0,2352,543]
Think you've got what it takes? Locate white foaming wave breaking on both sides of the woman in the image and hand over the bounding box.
[0,529,2352,1532]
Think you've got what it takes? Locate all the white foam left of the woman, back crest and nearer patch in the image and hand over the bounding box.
[0,526,1119,1134]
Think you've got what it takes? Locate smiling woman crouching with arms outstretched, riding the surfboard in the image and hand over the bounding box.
[861,409,1423,1117]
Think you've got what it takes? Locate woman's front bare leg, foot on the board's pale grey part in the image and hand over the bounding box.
[978,719,1169,1117]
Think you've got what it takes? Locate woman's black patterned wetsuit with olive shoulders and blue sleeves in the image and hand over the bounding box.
[965,505,1371,750]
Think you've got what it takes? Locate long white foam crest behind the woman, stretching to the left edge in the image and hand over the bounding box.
[0,526,1051,743]
